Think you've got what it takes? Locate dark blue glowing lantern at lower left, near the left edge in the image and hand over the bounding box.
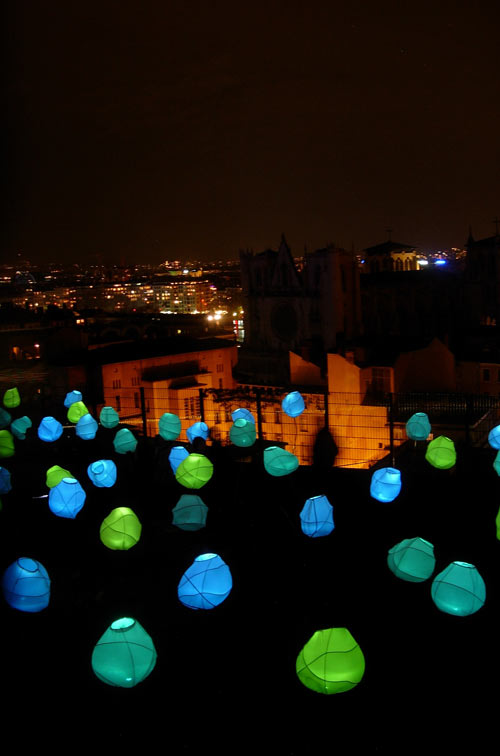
[2,557,50,612]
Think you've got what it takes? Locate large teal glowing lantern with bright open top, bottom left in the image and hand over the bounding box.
[92,617,157,688]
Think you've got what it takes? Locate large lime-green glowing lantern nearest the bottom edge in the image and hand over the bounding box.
[295,627,365,695]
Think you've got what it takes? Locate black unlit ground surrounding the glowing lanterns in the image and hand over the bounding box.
[0,428,500,754]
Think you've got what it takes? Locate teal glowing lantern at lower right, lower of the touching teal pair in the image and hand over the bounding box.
[431,562,486,617]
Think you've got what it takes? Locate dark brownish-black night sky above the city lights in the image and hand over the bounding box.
[2,0,500,262]
